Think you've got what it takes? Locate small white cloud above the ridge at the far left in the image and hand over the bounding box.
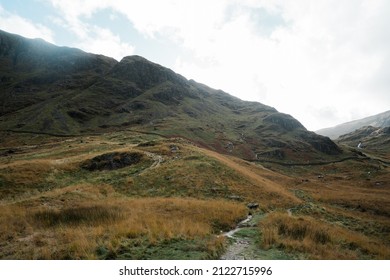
[0,5,54,43]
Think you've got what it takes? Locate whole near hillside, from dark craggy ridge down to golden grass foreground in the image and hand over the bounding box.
[0,31,390,260]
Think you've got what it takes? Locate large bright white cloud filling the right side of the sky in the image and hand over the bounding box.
[176,1,390,129]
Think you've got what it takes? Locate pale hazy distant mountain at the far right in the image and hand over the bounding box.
[316,111,390,139]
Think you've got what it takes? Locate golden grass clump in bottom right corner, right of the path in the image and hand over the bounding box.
[259,212,390,259]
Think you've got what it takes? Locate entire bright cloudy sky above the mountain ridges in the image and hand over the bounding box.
[0,0,390,130]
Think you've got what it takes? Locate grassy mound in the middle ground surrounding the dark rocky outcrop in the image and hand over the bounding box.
[0,130,302,209]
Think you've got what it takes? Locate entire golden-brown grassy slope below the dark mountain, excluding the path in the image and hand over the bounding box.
[0,132,390,259]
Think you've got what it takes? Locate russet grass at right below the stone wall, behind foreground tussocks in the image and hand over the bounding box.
[273,156,390,248]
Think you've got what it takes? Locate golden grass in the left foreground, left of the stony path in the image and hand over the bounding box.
[0,197,246,259]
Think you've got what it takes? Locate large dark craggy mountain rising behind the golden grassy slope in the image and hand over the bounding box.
[0,31,341,161]
